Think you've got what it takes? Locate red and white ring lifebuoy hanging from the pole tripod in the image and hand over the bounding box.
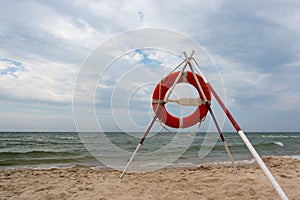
[152,71,211,128]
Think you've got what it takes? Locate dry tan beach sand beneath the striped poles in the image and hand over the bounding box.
[0,157,300,200]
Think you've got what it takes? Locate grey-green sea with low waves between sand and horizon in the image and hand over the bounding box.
[0,132,300,170]
